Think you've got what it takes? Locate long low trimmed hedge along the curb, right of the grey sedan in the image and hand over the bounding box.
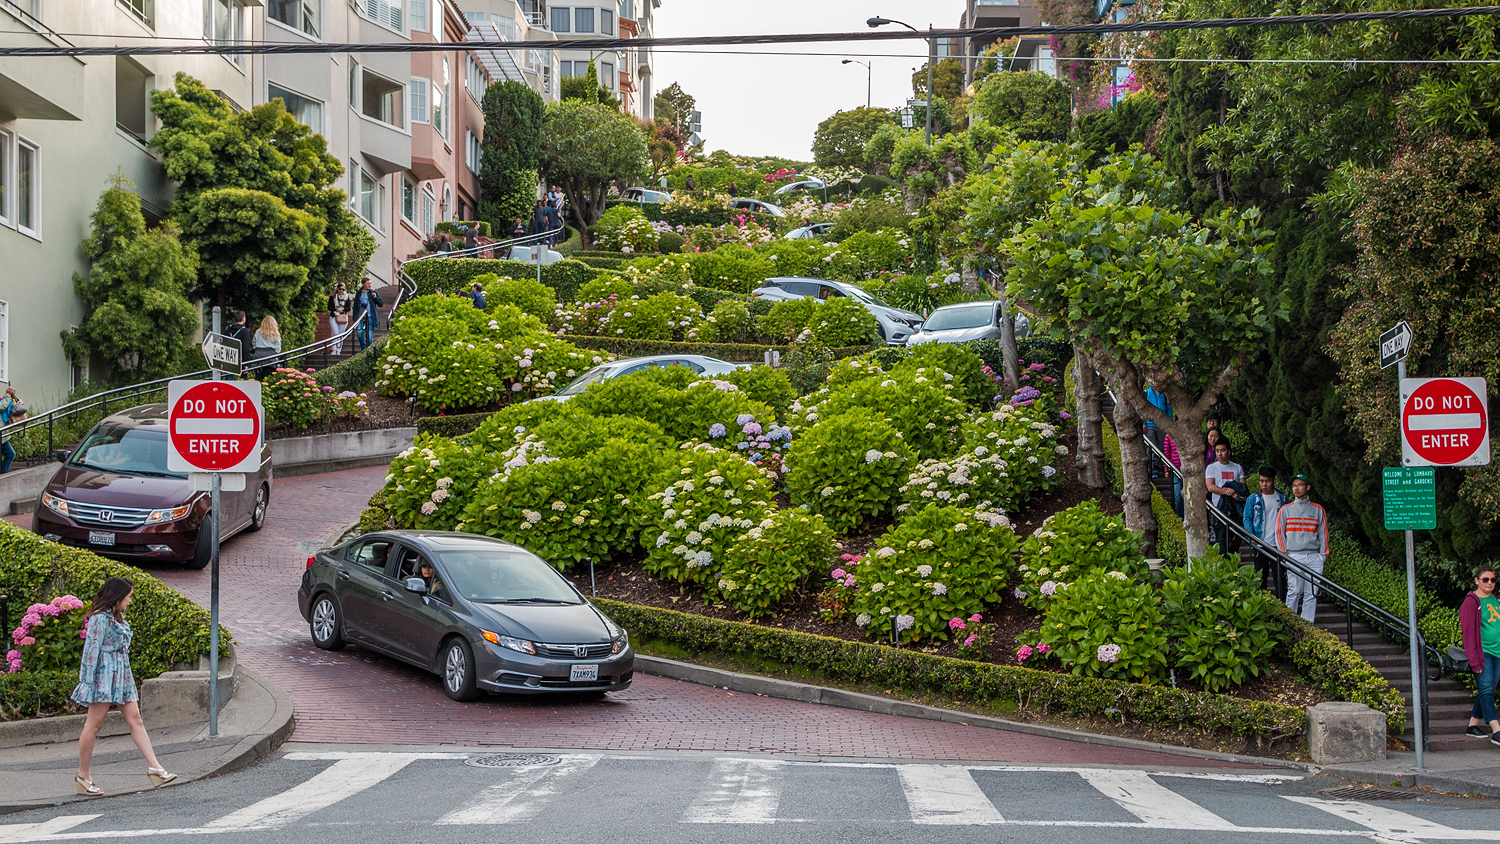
[591,598,1302,747]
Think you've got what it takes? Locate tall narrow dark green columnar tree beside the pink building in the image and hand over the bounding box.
[479,79,546,235]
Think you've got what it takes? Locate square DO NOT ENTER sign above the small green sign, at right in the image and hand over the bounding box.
[1401,378,1490,466]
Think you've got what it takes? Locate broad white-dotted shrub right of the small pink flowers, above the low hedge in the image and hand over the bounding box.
[851,507,1016,642]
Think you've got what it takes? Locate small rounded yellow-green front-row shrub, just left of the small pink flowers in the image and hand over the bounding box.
[710,510,836,618]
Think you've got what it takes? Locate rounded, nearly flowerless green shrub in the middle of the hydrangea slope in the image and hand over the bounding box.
[786,408,912,535]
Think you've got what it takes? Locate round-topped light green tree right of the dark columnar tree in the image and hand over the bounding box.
[542,100,651,231]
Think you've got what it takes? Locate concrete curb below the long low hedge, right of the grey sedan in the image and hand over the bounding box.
[636,654,1322,774]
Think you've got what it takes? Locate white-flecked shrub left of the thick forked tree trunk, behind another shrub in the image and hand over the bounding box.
[1017,501,1151,610]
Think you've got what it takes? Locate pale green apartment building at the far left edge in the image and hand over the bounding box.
[0,0,264,406]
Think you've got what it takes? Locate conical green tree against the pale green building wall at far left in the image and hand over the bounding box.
[63,183,198,381]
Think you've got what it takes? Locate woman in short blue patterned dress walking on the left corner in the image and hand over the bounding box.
[72,577,177,796]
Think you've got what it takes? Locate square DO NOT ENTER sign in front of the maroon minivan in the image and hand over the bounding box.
[167,381,266,472]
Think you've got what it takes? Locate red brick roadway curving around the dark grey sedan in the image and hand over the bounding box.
[132,468,1254,766]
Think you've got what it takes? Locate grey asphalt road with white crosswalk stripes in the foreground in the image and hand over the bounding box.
[0,745,1500,844]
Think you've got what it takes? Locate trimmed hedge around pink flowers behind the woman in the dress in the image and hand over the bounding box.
[0,522,231,711]
